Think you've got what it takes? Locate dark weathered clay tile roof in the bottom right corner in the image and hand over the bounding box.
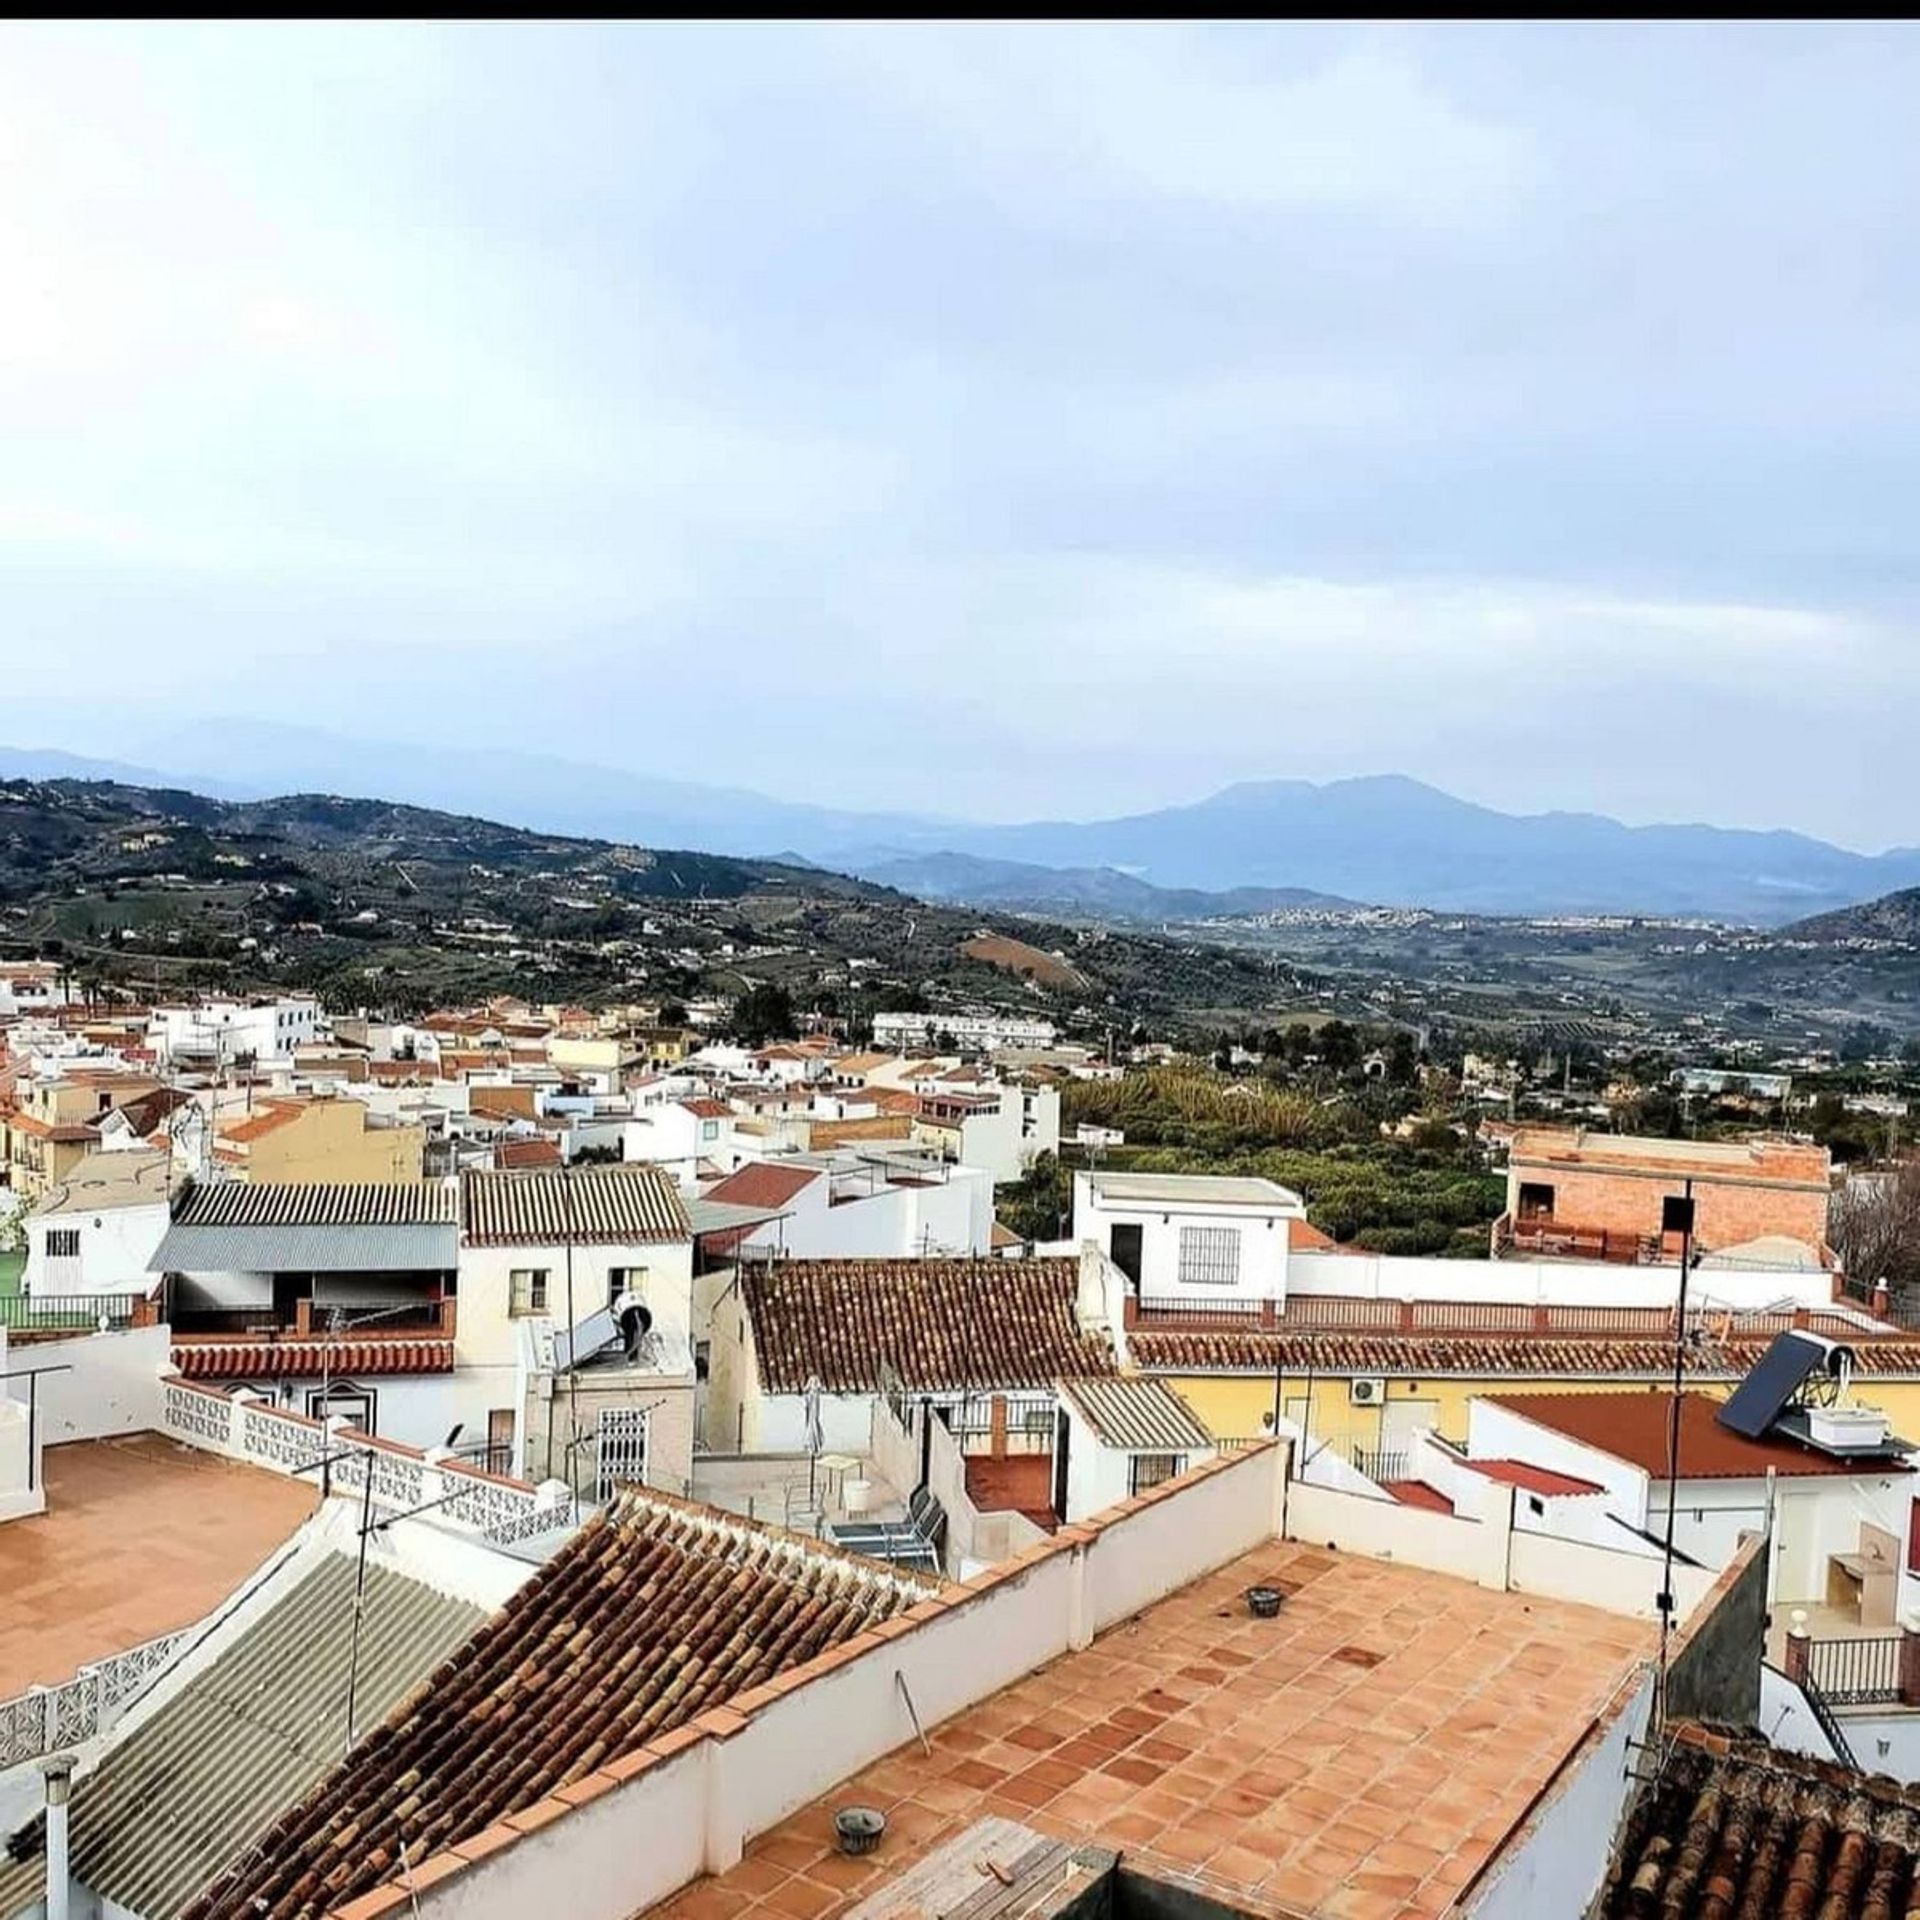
[1594,1726,1920,1920]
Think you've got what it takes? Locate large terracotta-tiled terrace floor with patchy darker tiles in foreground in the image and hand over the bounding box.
[655,1542,1653,1920]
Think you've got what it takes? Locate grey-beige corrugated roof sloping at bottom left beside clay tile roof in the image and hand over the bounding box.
[0,1553,486,1920]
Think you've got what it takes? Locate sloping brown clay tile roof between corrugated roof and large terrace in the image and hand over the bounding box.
[192,1494,933,1920]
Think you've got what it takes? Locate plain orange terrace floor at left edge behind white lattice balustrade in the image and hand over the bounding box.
[0,1434,319,1699]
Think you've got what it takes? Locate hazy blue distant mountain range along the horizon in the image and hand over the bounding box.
[0,720,1920,925]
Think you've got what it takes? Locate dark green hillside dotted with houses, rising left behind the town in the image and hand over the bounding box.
[0,780,1294,1021]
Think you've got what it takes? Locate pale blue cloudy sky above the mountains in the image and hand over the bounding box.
[0,23,1920,849]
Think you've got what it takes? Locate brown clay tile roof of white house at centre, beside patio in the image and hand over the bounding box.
[741,1260,1114,1394]
